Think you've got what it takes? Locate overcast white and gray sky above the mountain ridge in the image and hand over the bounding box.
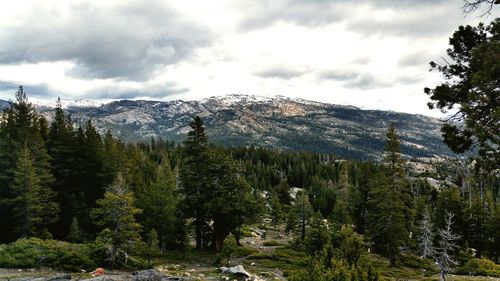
[0,0,499,117]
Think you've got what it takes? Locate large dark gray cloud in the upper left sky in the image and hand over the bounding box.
[0,0,211,81]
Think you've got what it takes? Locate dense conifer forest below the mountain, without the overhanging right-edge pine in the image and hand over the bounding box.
[0,87,500,280]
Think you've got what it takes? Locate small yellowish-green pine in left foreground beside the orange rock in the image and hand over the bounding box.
[92,174,142,268]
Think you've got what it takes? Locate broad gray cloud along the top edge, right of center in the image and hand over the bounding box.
[240,0,461,39]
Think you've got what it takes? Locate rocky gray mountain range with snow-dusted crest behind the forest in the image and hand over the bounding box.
[0,95,453,159]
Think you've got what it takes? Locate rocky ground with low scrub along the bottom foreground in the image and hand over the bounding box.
[0,223,500,281]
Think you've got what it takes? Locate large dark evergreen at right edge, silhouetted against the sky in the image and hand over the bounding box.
[424,19,500,171]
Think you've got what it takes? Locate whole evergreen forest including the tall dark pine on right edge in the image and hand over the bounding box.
[0,0,500,281]
